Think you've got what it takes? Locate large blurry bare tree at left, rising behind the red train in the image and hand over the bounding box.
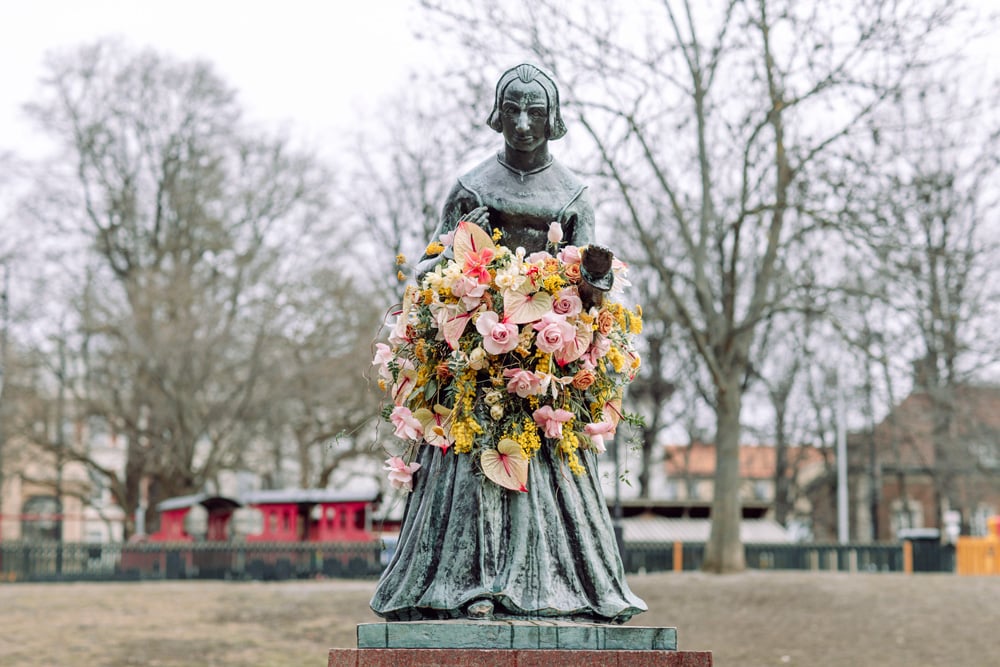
[20,42,327,534]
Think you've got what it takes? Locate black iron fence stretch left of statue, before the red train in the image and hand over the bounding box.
[0,541,383,581]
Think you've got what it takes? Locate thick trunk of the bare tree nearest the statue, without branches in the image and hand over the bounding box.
[702,373,746,574]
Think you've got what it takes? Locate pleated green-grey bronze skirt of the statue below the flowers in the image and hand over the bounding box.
[371,446,646,623]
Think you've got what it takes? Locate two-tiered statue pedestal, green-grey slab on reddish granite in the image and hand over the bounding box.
[328,621,712,667]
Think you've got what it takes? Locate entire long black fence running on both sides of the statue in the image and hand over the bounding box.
[0,541,955,581]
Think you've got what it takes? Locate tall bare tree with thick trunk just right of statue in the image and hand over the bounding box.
[416,0,949,572]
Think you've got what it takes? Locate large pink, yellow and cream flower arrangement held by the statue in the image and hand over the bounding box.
[373,221,642,491]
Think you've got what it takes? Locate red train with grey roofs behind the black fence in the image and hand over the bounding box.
[121,489,395,579]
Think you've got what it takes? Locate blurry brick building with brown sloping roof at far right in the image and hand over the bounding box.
[813,385,1000,541]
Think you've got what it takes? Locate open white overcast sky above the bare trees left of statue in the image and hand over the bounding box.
[0,0,429,159]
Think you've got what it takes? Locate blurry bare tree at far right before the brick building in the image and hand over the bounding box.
[844,73,1000,526]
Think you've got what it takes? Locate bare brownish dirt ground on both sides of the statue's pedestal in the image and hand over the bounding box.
[0,572,1000,667]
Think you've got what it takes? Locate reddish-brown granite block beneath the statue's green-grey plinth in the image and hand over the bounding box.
[328,648,712,667]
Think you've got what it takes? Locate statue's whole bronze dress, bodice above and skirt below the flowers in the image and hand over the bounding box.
[371,158,646,622]
